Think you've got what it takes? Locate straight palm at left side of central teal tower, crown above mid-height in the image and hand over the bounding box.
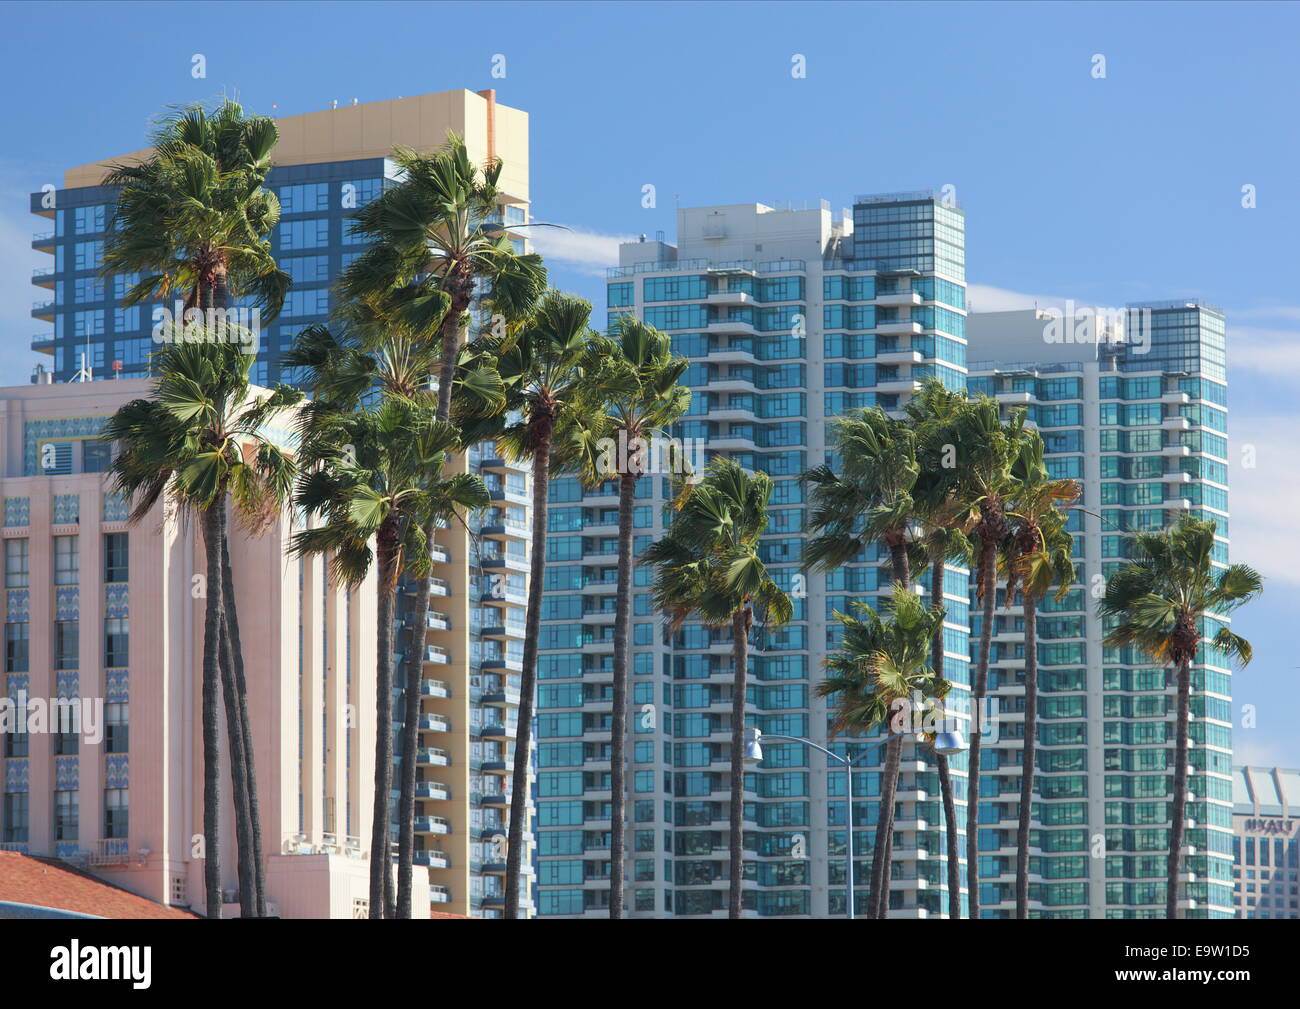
[579,316,690,918]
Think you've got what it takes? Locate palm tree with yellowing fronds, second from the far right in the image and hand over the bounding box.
[1002,430,1079,918]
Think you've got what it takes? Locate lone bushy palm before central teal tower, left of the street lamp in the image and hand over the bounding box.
[642,459,793,918]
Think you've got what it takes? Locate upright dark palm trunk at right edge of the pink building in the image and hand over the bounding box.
[371,540,397,918]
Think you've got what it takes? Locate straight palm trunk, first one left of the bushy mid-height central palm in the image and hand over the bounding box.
[610,473,637,918]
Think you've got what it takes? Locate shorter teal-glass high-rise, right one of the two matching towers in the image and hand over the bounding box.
[967,300,1234,918]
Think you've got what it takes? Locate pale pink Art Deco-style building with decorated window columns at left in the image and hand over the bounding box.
[0,378,410,918]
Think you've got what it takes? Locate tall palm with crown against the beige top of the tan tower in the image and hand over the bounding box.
[341,134,546,918]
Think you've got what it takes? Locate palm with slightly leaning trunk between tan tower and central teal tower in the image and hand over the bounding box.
[462,291,595,918]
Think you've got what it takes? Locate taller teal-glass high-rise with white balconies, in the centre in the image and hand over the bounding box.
[537,192,969,918]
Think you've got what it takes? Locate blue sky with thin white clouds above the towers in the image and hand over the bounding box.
[0,3,1300,766]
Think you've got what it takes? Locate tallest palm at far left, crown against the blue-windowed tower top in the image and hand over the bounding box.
[103,100,290,915]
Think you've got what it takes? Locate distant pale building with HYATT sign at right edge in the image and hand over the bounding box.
[1232,766,1300,918]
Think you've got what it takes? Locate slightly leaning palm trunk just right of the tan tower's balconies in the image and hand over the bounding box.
[504,415,555,918]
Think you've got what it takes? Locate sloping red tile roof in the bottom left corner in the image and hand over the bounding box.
[0,852,198,918]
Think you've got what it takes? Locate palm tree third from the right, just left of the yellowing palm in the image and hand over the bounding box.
[936,397,1024,918]
